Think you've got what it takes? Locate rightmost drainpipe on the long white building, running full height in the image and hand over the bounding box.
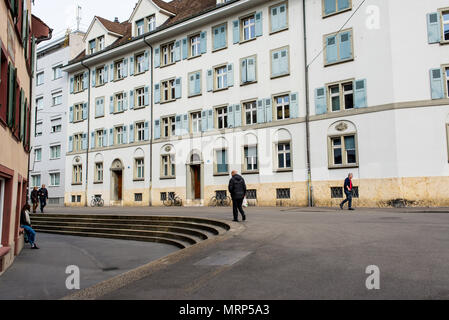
[302,0,314,207]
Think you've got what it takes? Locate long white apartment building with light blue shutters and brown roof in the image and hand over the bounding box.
[64,0,449,206]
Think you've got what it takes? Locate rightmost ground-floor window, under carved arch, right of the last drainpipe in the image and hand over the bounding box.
[329,135,357,167]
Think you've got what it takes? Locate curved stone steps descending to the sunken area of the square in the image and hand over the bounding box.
[30,214,230,249]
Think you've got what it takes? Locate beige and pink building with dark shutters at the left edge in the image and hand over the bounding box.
[0,0,51,274]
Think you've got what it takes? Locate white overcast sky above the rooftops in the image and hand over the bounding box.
[32,0,168,39]
